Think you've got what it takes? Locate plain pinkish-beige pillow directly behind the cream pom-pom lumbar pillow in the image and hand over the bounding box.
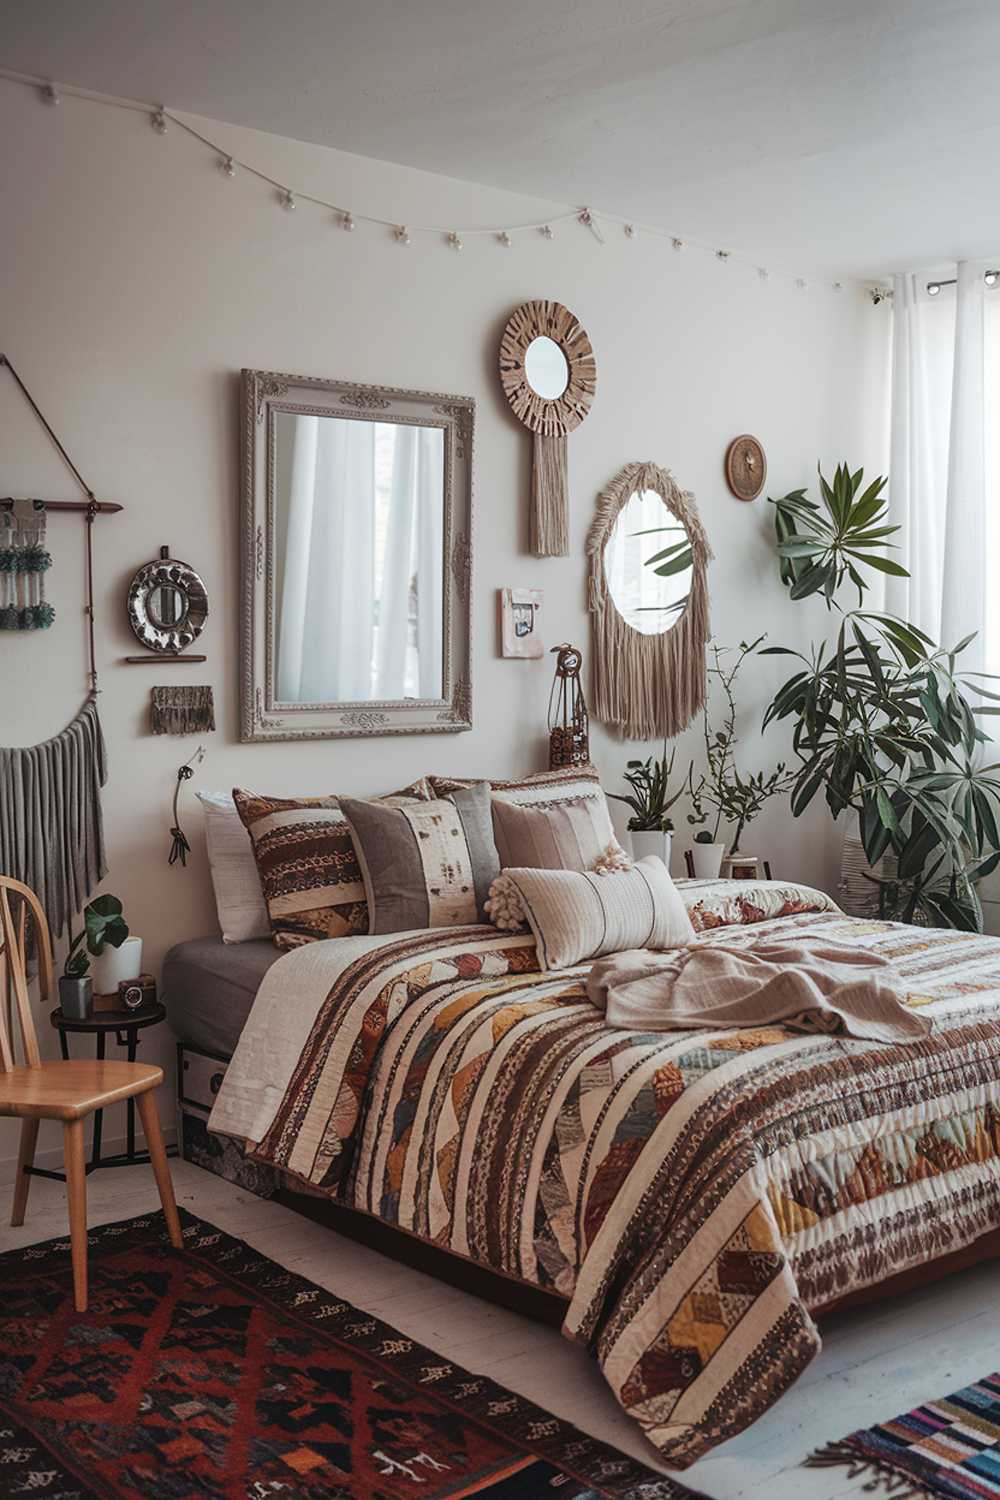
[493,792,618,870]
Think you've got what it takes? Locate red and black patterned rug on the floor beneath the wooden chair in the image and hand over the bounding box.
[0,1214,704,1500]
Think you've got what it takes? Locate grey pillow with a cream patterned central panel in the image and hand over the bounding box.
[342,782,499,933]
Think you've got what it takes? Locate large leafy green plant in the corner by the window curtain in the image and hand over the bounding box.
[763,465,1000,932]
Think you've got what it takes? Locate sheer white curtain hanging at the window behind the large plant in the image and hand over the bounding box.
[886,263,1000,671]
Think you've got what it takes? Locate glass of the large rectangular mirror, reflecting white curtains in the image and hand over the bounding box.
[276,414,444,702]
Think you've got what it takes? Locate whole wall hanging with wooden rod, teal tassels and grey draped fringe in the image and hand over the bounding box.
[0,354,121,938]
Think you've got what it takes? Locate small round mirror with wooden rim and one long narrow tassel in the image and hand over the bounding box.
[499,302,597,558]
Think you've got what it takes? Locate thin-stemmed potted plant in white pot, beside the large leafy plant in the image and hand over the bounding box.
[688,636,795,879]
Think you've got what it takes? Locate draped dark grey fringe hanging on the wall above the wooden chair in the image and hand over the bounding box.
[0,698,108,938]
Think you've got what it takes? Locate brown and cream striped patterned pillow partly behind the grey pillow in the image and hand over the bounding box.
[232,780,430,948]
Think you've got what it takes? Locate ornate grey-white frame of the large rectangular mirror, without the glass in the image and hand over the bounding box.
[240,369,475,744]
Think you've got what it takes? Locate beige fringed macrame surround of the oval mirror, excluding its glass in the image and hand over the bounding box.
[586,464,712,740]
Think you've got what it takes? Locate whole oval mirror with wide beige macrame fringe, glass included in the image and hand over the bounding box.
[586,464,712,740]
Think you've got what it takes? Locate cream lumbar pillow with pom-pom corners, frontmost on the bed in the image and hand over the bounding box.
[487,855,694,969]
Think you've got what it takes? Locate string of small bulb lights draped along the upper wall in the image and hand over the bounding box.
[0,68,863,294]
